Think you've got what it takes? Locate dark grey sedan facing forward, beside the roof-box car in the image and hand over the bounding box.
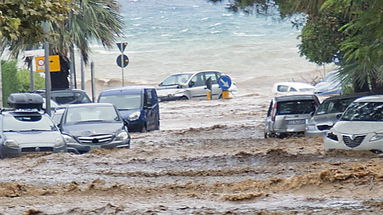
[55,103,130,153]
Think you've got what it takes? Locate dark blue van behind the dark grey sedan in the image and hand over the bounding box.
[98,86,160,132]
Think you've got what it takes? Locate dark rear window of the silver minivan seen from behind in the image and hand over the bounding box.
[277,100,316,115]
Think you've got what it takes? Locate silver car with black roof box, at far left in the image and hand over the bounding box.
[0,93,67,158]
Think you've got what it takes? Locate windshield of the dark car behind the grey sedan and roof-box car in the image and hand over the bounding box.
[52,91,91,104]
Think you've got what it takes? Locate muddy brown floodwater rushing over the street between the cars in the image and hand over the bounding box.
[0,94,383,214]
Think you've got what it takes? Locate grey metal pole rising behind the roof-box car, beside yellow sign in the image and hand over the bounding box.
[43,22,52,116]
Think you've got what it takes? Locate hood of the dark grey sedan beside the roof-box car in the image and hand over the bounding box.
[63,123,123,137]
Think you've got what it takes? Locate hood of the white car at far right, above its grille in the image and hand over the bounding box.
[332,121,383,134]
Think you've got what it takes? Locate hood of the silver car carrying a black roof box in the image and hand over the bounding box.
[4,131,62,145]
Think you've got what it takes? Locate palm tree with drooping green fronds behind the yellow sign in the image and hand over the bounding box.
[50,0,123,88]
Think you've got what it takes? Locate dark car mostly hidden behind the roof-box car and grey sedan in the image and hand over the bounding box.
[34,89,92,106]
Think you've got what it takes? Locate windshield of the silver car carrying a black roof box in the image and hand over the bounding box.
[3,115,57,132]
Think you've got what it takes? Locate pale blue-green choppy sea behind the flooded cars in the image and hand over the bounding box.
[87,0,317,91]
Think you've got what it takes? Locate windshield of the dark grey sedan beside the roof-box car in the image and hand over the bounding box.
[65,106,120,123]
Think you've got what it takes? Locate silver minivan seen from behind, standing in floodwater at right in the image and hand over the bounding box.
[264,95,320,138]
